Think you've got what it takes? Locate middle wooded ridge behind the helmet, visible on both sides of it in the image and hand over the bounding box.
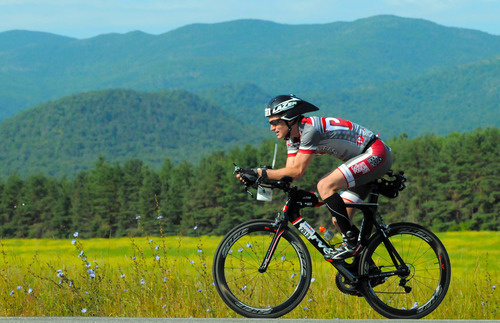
[196,56,500,139]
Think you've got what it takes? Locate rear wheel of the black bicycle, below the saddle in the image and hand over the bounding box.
[359,223,451,319]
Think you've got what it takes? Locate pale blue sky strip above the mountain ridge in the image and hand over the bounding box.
[0,0,500,38]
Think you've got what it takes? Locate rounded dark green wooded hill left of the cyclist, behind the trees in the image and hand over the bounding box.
[0,90,263,177]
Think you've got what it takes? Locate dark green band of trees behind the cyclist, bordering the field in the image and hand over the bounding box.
[0,128,500,238]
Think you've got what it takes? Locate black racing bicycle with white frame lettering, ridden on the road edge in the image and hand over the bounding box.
[213,166,451,319]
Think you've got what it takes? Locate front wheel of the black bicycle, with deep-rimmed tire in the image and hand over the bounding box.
[213,220,312,318]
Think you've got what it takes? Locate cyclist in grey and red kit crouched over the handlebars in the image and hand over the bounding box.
[237,95,392,261]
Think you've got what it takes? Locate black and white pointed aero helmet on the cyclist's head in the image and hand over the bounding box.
[265,94,319,121]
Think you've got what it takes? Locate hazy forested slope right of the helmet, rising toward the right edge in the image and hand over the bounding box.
[304,56,500,138]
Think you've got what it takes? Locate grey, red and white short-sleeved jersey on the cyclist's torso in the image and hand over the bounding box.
[287,117,376,161]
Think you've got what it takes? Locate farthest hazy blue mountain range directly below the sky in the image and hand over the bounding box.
[0,16,500,120]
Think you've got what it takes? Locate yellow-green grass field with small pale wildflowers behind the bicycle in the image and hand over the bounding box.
[0,232,500,319]
